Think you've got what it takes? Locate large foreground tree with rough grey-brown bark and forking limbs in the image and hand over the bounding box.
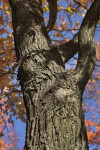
[9,0,100,150]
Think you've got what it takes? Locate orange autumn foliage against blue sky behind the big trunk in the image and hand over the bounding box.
[0,0,100,150]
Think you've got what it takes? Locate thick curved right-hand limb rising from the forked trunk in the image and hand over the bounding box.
[74,0,100,90]
